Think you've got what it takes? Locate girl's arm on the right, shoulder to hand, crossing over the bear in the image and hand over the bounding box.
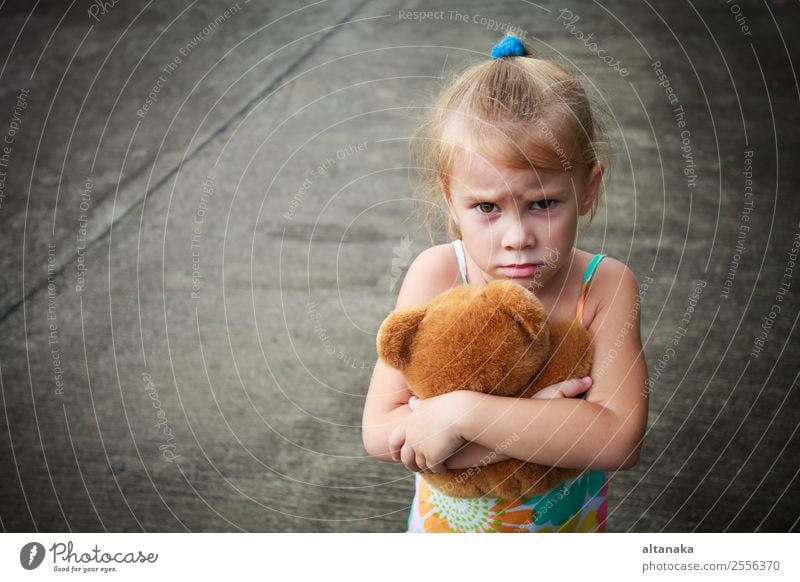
[390,259,647,472]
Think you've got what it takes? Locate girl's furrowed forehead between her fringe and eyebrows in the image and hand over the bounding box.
[451,148,573,193]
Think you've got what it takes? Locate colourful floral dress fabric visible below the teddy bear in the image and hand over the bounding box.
[408,471,608,533]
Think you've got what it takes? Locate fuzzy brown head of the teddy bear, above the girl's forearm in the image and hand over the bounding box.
[377,281,550,398]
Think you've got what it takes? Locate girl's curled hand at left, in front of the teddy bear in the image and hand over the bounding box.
[389,390,471,473]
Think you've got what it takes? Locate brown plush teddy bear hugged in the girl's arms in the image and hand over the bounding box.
[377,281,592,499]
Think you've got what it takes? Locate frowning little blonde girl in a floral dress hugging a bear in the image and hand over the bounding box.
[363,36,647,532]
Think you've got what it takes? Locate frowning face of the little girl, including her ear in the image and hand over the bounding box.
[447,150,602,292]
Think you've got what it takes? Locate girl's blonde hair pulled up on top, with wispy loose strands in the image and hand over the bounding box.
[411,40,610,239]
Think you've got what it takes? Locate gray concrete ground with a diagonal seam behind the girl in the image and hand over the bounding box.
[0,0,800,532]
